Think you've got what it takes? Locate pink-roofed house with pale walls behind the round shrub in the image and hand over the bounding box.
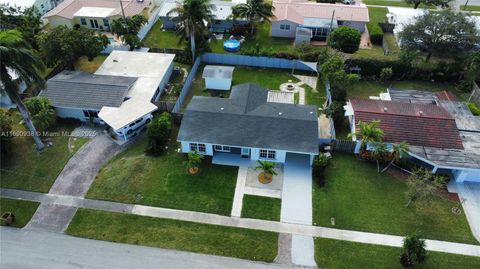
[271,0,369,45]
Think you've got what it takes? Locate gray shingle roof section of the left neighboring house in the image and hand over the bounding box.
[40,71,136,110]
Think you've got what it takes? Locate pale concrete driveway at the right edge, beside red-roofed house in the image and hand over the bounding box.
[456,182,480,242]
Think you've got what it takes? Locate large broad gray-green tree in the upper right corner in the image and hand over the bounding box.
[399,10,480,60]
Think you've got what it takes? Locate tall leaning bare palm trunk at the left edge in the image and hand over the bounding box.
[0,66,45,151]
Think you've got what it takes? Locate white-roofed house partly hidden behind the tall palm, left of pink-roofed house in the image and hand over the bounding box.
[158,0,248,33]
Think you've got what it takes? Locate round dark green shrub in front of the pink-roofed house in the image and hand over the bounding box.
[327,26,361,53]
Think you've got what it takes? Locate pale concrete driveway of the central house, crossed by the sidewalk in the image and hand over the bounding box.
[280,153,317,267]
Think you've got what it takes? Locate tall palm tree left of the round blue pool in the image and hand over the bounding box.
[167,0,215,61]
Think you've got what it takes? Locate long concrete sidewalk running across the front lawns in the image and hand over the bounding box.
[0,189,480,257]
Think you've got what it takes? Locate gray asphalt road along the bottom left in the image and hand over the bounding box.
[0,227,287,269]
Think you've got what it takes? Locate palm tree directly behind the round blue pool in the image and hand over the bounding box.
[233,0,274,36]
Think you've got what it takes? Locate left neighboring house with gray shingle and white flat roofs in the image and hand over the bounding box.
[40,51,175,140]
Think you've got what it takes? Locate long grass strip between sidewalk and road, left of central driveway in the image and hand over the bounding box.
[66,209,278,262]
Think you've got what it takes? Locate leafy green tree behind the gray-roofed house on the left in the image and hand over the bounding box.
[37,26,109,69]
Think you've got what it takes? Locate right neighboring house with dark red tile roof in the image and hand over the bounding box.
[345,97,480,182]
